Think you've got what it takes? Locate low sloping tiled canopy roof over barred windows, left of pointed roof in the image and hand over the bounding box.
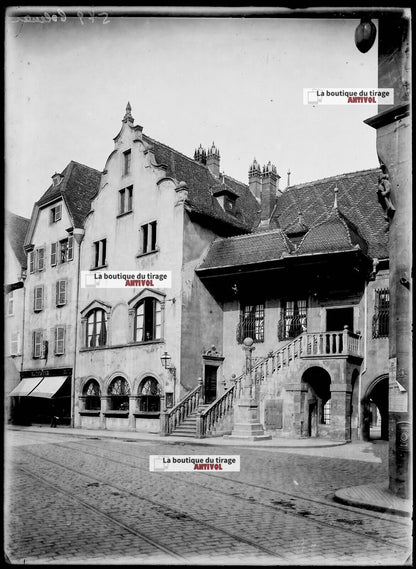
[198,229,293,270]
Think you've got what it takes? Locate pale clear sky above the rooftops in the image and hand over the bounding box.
[5,8,378,217]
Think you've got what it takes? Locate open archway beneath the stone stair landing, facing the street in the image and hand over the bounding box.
[301,367,331,437]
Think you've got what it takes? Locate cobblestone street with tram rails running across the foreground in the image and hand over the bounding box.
[5,430,411,565]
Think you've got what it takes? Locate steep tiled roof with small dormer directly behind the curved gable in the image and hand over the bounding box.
[143,135,259,232]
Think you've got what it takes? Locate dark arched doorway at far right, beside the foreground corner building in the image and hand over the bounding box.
[363,375,389,441]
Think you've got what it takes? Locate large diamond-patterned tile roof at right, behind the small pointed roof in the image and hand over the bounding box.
[271,168,388,259]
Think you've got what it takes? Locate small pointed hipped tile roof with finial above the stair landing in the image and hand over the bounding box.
[296,208,368,255]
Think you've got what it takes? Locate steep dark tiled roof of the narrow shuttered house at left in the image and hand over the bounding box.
[36,160,101,227]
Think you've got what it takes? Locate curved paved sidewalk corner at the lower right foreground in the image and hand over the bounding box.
[334,482,412,516]
